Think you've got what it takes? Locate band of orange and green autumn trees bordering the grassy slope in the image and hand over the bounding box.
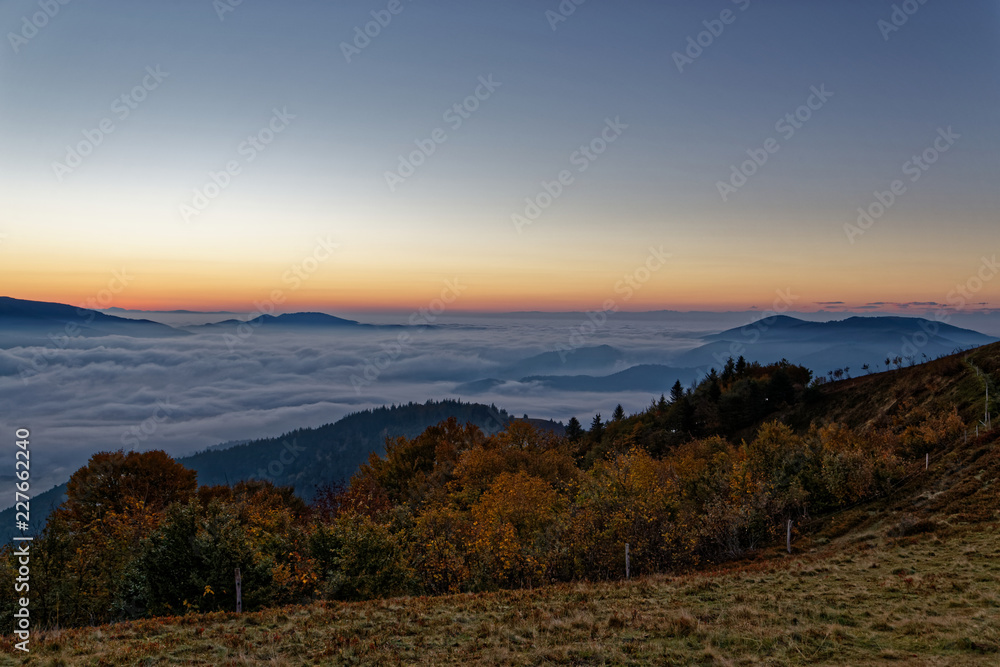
[0,364,963,627]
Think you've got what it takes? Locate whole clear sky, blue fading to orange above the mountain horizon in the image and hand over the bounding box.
[0,0,1000,313]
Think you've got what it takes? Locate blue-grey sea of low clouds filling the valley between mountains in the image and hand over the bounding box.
[0,313,1000,492]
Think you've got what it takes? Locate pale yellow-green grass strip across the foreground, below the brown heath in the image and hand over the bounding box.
[0,524,1000,665]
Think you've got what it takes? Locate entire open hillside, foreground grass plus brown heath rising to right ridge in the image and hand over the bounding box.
[0,345,1000,665]
